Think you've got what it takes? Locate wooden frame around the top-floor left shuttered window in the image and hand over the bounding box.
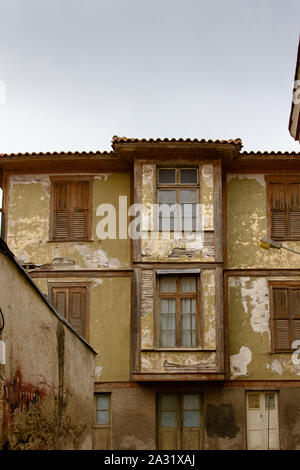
[49,176,93,243]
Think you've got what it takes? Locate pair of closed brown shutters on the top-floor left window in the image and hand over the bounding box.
[51,178,91,241]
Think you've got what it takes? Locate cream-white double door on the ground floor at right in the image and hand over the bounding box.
[246,391,279,450]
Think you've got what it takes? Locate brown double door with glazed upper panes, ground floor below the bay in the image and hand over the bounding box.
[157,393,203,450]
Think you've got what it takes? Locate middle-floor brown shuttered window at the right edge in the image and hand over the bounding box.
[270,281,300,352]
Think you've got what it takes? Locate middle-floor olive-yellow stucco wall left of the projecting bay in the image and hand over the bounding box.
[35,277,131,382]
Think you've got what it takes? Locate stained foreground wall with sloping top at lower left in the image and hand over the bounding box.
[0,254,94,449]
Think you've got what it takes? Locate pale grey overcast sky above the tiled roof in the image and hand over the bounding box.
[0,0,300,153]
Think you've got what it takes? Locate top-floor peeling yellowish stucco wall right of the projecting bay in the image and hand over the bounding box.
[227,174,300,269]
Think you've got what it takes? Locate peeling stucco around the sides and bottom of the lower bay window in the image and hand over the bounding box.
[140,269,216,372]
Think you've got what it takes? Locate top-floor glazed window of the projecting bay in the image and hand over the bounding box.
[157,168,199,231]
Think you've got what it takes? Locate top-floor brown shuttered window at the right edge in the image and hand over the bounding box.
[266,176,300,240]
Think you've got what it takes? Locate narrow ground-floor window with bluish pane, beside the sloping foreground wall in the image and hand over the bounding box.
[94,393,111,450]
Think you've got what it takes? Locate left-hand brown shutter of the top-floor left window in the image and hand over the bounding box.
[54,182,71,240]
